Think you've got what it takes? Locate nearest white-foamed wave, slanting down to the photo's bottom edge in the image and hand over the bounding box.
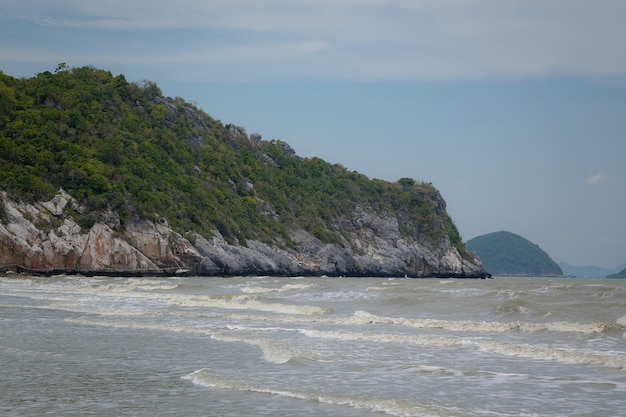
[182,369,465,417]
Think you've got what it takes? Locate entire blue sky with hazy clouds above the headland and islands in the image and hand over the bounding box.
[0,0,626,268]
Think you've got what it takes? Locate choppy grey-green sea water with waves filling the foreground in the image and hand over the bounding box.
[0,277,626,417]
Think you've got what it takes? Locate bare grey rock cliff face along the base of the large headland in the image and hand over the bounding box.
[0,190,486,278]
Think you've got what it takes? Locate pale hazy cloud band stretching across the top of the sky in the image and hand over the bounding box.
[2,0,626,79]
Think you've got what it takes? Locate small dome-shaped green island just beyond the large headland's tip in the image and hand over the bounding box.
[465,231,563,276]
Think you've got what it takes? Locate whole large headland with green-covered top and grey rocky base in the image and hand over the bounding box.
[0,65,483,276]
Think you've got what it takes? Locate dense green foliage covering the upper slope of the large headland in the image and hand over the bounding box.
[0,64,465,254]
